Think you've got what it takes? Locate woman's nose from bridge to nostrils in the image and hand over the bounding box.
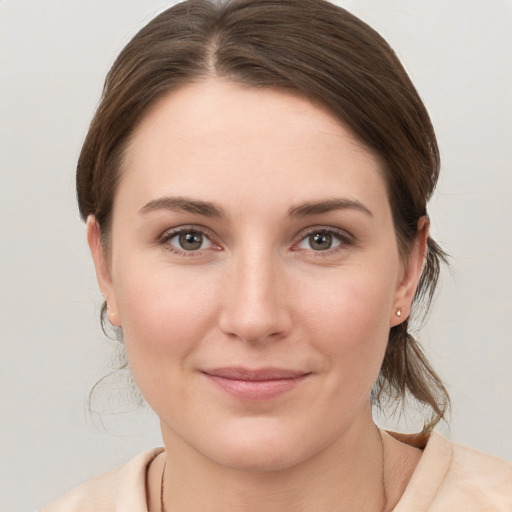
[219,248,292,343]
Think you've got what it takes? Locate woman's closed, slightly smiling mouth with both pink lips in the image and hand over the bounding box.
[201,368,311,401]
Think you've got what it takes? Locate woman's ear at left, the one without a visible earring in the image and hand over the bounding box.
[87,215,121,327]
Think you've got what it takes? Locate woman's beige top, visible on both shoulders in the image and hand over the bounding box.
[40,433,512,512]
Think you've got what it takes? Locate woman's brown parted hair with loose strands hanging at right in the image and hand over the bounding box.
[77,0,449,429]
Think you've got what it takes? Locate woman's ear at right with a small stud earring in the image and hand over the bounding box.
[390,215,430,327]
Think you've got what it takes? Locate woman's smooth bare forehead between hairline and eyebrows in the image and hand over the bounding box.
[118,79,385,216]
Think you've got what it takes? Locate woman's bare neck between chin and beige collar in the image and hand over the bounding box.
[163,412,387,512]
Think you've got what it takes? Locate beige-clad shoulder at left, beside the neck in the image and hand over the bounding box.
[40,448,163,512]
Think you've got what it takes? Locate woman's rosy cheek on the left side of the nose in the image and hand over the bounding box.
[116,264,218,382]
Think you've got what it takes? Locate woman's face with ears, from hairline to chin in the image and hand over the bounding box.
[88,79,426,470]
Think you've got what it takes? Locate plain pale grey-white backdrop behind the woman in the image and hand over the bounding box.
[0,0,512,512]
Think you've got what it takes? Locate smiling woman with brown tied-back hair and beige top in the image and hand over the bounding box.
[44,0,512,512]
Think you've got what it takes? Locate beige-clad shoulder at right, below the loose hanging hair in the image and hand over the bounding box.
[395,433,512,512]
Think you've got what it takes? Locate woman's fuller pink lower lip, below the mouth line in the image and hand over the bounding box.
[204,374,308,401]
